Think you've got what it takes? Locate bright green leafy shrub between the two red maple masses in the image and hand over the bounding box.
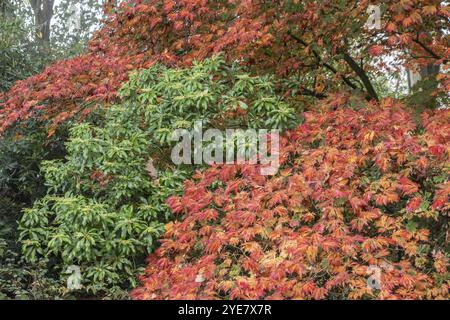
[20,57,300,297]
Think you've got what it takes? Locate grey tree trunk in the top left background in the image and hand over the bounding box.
[30,0,55,46]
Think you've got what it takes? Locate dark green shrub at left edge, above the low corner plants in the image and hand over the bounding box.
[0,121,65,245]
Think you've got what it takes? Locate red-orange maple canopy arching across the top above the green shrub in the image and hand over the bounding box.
[0,0,450,132]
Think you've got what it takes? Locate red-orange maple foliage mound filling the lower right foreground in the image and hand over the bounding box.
[132,96,450,299]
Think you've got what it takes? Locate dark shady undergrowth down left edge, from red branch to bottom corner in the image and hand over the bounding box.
[0,120,64,299]
